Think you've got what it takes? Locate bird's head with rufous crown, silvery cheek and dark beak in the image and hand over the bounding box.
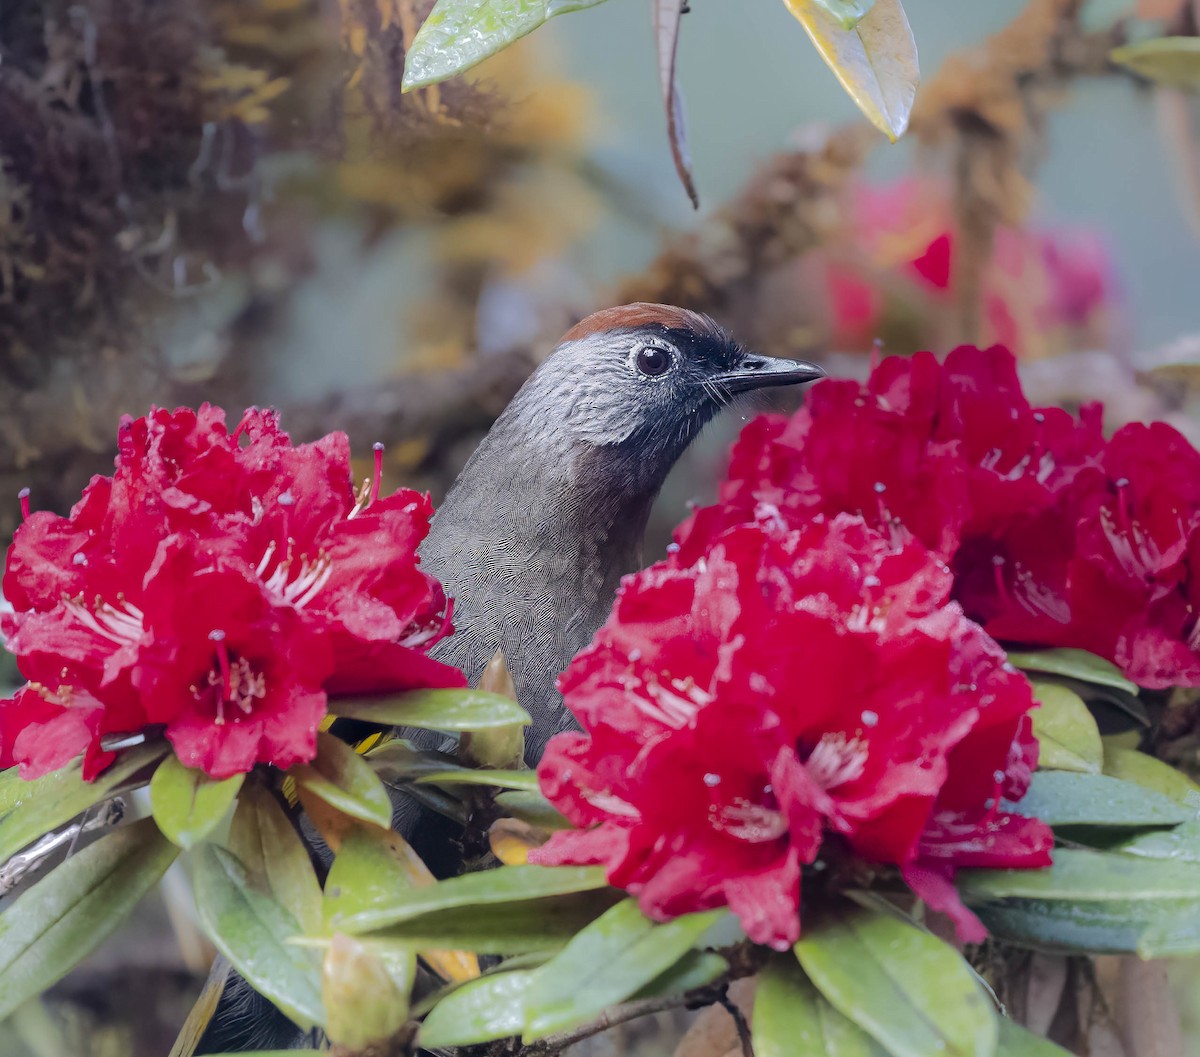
[522,304,824,468]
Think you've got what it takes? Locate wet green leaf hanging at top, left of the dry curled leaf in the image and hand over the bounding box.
[403,0,602,91]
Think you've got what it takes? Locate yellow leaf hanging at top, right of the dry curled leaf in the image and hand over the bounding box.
[784,0,920,143]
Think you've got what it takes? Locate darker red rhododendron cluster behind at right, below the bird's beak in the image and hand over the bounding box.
[679,347,1200,687]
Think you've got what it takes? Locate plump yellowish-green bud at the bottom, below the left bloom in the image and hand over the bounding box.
[320,932,416,1050]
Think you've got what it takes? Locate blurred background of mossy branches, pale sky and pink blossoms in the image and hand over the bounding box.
[0,0,1200,1057]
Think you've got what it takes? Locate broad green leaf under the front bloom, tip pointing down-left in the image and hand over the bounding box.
[524,899,726,1040]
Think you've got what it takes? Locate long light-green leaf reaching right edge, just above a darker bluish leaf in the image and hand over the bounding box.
[955,848,1200,903]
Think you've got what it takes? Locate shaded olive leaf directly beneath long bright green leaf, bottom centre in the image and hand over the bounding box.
[328,887,619,954]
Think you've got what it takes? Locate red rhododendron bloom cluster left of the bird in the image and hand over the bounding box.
[0,406,463,777]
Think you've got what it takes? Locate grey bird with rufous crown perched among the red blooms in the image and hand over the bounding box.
[197,302,824,1053]
